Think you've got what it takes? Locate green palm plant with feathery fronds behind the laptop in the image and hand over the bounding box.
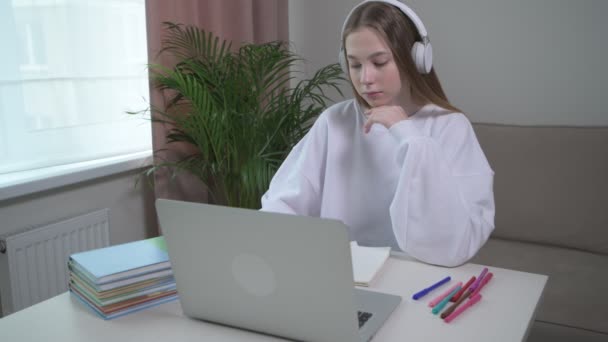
[139,23,343,209]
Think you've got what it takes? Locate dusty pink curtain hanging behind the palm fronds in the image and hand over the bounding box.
[146,0,289,208]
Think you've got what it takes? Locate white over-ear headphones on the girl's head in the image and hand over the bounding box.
[339,0,433,75]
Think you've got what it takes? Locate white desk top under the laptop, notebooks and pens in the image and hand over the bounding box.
[0,256,547,342]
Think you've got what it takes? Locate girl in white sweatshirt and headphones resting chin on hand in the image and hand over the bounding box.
[262,0,494,266]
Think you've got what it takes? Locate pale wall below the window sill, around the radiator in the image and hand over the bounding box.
[0,171,156,317]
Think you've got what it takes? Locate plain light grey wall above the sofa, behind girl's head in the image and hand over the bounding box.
[289,0,608,126]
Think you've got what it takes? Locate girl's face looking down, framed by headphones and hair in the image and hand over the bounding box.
[344,27,409,107]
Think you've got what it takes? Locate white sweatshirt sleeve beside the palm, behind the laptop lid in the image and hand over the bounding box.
[260,115,327,217]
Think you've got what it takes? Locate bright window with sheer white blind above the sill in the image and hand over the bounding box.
[0,0,152,175]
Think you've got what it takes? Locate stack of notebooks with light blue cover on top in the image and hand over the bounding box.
[68,237,177,319]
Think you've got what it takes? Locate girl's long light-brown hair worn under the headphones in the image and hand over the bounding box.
[342,1,462,112]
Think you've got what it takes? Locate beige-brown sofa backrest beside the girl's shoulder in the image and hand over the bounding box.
[474,123,608,254]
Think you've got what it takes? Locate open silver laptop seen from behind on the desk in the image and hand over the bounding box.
[156,199,401,342]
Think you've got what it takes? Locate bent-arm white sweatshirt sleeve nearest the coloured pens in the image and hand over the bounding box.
[389,114,495,267]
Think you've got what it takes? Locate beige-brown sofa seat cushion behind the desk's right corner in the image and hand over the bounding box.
[472,238,608,333]
